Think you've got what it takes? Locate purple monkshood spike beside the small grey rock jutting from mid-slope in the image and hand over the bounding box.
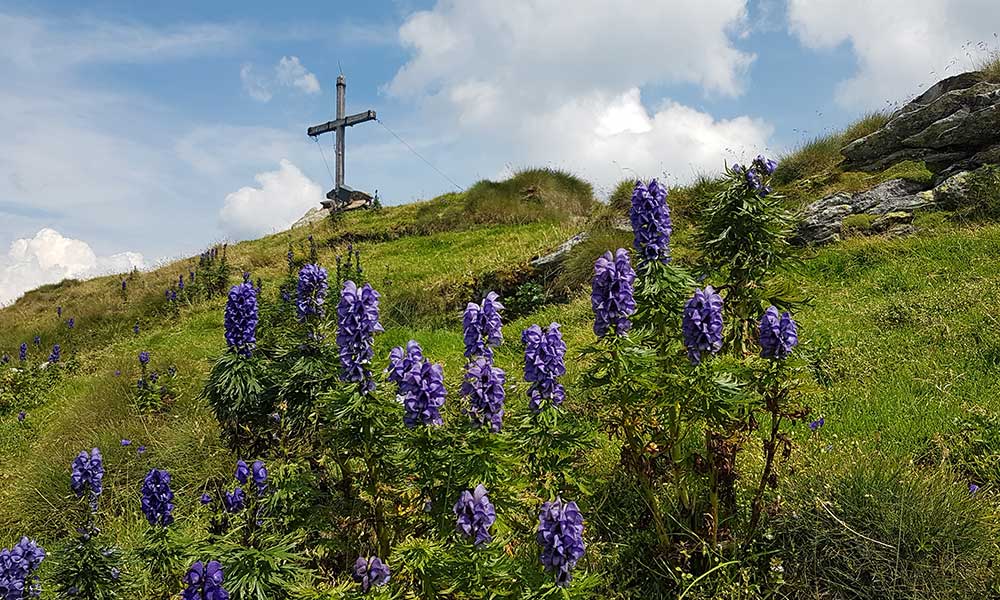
[590,248,635,337]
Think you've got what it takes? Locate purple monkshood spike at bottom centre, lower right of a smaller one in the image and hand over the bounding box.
[535,498,586,587]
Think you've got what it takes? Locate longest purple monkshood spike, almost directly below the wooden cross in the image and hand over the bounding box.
[337,280,384,393]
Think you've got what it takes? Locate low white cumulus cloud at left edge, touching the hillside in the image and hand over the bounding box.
[0,228,145,305]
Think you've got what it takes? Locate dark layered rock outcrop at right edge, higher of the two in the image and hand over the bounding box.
[841,73,1000,181]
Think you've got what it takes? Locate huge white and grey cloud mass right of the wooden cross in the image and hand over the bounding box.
[387,0,772,188]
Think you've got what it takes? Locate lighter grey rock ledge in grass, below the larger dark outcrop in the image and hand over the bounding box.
[794,179,933,245]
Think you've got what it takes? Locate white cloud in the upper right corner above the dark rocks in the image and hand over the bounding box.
[788,0,1000,108]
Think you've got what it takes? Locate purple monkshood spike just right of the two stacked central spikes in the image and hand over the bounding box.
[521,323,566,412]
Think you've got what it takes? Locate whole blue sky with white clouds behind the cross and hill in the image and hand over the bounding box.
[0,0,1000,303]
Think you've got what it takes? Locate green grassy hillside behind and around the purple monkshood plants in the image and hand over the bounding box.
[0,146,1000,598]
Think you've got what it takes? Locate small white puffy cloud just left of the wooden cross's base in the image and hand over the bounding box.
[219,159,325,239]
